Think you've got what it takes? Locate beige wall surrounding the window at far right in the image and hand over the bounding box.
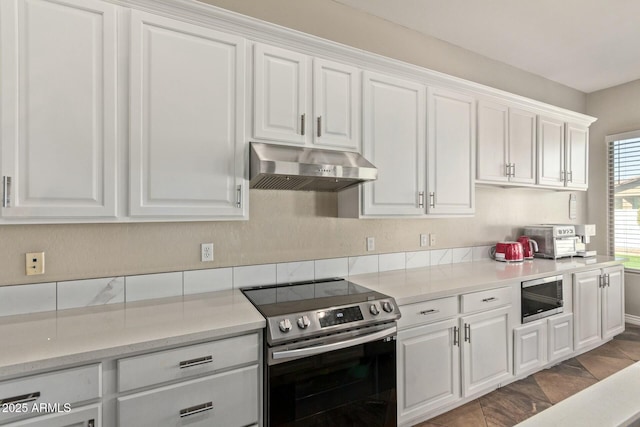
[587,80,640,316]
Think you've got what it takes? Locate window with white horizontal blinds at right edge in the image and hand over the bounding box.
[607,131,640,271]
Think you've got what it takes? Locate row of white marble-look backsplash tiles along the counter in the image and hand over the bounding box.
[0,246,489,316]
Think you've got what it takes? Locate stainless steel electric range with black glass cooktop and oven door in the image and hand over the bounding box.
[242,279,400,427]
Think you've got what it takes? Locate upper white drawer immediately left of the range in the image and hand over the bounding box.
[118,334,259,391]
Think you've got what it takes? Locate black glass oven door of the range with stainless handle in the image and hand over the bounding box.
[265,326,397,427]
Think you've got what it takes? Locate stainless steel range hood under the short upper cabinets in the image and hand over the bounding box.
[249,142,378,191]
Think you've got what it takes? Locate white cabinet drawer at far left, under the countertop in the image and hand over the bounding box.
[0,364,102,423]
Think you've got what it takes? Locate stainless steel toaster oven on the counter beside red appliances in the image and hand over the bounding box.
[524,225,576,259]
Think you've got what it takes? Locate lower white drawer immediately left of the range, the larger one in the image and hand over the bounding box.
[118,365,259,427]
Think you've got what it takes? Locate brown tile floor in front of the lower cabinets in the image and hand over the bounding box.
[415,324,640,427]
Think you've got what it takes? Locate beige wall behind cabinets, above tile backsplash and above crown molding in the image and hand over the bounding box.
[0,0,586,285]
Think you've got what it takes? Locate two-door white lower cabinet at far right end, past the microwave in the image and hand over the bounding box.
[573,266,624,350]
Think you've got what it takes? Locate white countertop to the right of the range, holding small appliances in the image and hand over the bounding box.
[349,256,622,305]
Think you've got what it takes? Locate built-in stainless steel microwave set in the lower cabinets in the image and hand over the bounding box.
[521,275,564,323]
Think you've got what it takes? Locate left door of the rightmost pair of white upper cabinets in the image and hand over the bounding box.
[538,116,566,187]
